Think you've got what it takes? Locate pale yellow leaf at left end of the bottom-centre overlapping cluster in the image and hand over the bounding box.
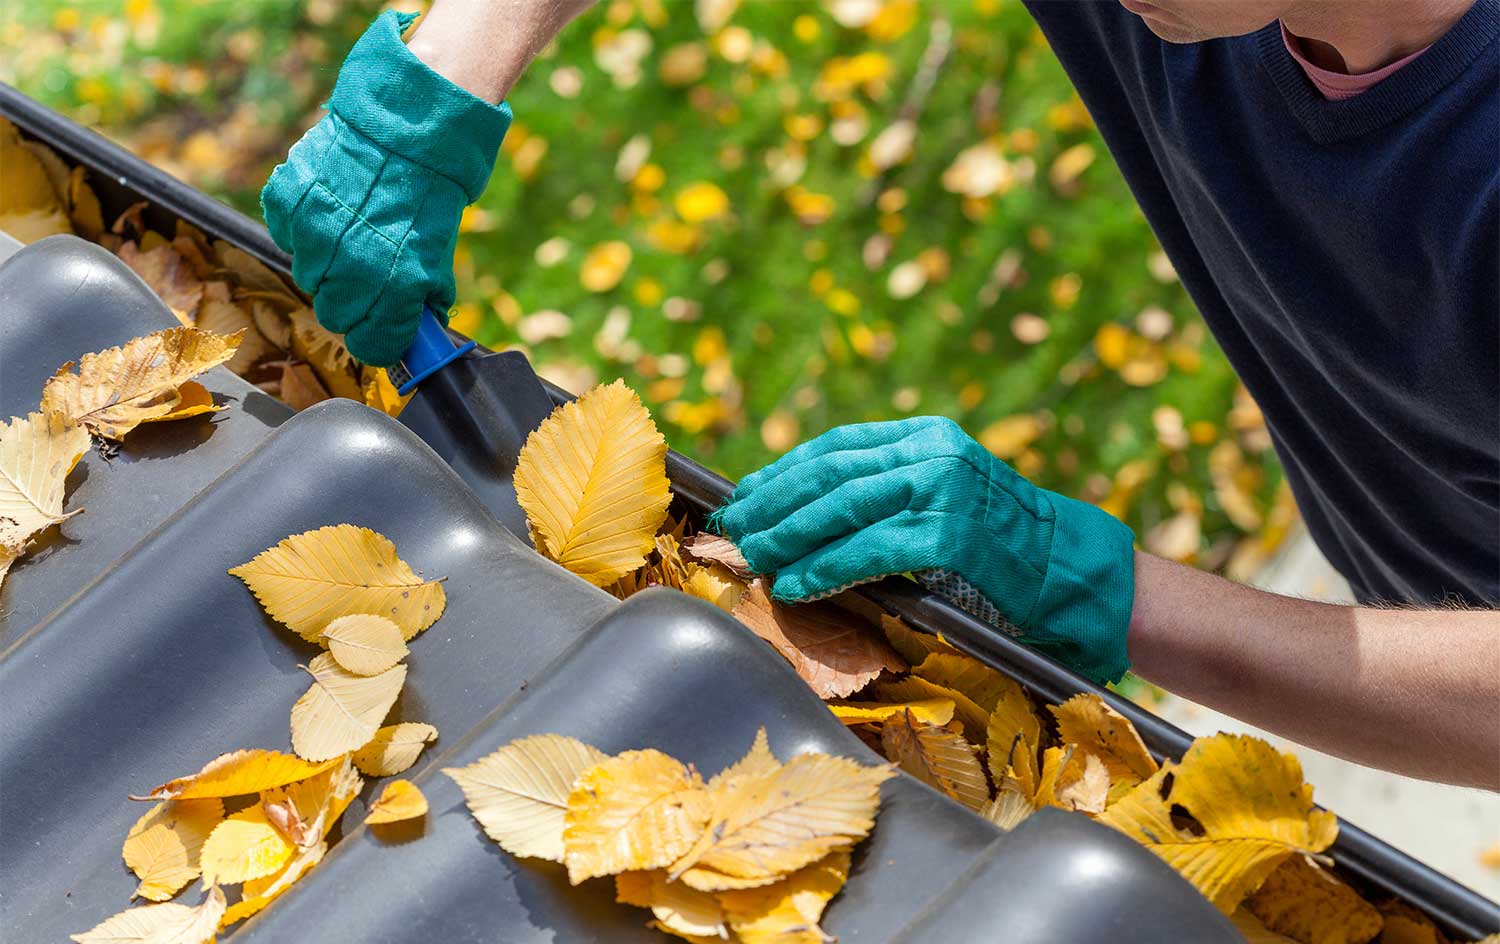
[443,734,609,861]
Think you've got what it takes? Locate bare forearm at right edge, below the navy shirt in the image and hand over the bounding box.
[1128,554,1500,789]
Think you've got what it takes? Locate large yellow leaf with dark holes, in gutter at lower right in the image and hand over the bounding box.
[1098,734,1338,914]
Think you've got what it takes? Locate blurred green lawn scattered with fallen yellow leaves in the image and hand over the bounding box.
[0,0,1292,573]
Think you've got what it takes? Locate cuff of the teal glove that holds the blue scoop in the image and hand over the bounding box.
[329,11,510,203]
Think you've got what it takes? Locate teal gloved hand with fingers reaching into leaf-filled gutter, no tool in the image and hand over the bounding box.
[714,416,1136,681]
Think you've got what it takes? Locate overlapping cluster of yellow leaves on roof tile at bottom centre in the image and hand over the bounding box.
[444,729,894,944]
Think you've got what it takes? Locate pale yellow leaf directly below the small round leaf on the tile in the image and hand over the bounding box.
[291,653,407,761]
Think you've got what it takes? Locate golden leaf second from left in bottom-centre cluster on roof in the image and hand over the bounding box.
[563,749,708,885]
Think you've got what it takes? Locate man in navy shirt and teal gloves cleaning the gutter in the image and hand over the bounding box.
[264,0,1500,789]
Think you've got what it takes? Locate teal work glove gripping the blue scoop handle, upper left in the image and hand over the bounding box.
[261,12,510,366]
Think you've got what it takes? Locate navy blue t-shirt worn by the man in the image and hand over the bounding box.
[1029,0,1500,606]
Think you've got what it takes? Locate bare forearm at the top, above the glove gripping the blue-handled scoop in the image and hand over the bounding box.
[407,0,593,104]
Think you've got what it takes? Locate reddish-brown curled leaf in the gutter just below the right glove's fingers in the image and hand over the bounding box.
[735,578,900,701]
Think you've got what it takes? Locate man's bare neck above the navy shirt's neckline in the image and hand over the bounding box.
[1281,0,1475,75]
